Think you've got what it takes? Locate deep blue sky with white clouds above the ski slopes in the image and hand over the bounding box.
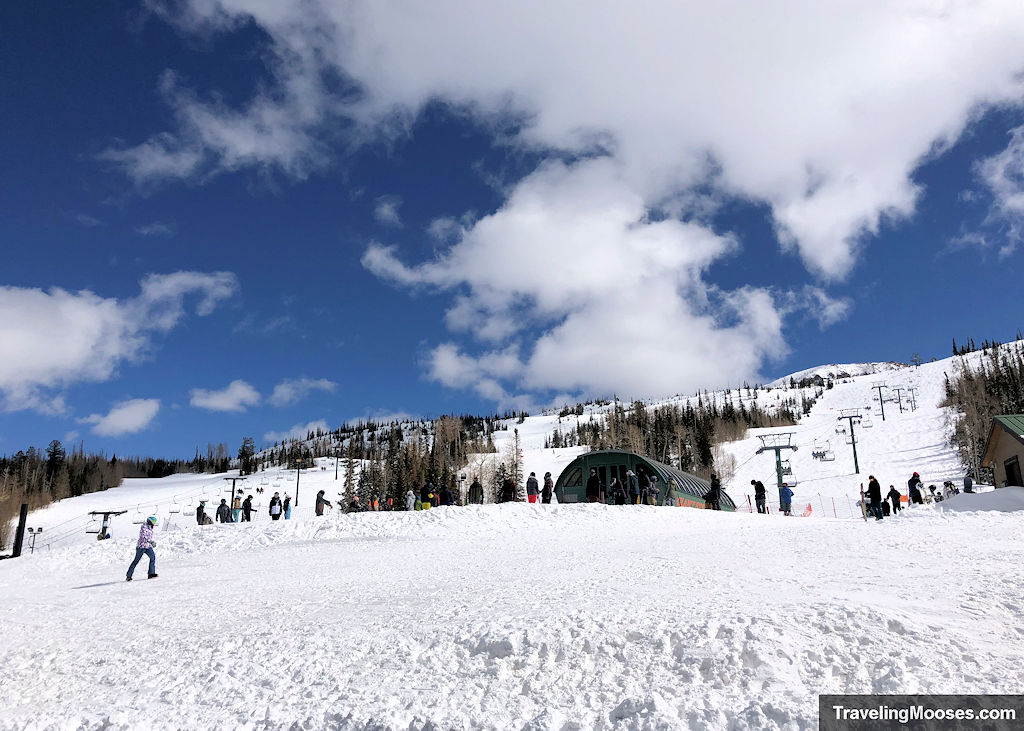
[0,0,1024,457]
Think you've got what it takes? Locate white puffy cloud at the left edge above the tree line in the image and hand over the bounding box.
[0,271,239,414]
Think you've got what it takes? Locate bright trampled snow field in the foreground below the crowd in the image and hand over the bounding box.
[0,503,1024,729]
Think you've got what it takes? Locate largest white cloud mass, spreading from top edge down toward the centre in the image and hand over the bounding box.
[109,0,1024,400]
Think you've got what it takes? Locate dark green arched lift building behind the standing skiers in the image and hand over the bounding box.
[555,449,736,511]
